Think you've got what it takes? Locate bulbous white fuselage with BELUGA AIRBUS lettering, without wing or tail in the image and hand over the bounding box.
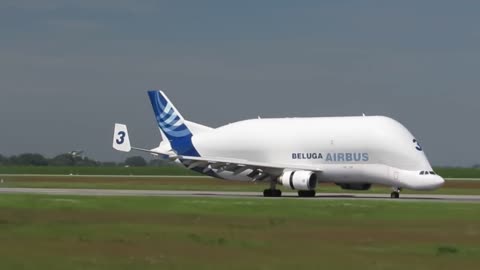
[192,116,444,189]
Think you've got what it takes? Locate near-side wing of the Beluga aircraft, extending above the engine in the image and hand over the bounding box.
[176,156,322,181]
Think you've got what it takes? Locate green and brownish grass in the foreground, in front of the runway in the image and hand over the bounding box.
[0,195,480,270]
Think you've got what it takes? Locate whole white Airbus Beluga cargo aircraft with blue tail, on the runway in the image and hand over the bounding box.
[113,90,444,198]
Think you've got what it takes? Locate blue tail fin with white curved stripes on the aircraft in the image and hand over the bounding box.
[148,90,200,157]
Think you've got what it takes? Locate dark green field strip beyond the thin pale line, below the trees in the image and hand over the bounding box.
[0,166,480,178]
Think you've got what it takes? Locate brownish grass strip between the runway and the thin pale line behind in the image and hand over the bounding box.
[0,176,480,195]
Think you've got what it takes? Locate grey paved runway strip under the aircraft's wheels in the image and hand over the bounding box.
[0,188,480,203]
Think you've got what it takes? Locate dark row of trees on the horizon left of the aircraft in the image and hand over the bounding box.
[0,153,168,167]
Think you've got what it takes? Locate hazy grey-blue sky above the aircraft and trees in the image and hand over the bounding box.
[0,0,480,166]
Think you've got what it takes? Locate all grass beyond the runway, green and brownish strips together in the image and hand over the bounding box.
[0,166,480,195]
